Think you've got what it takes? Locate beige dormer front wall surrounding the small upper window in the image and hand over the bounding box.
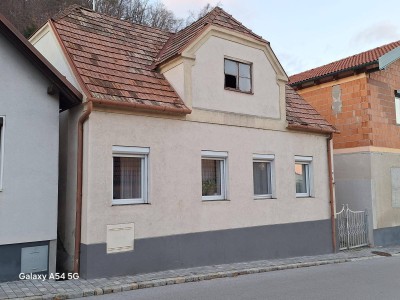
[192,36,281,119]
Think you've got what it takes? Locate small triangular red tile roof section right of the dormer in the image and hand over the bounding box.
[286,85,337,133]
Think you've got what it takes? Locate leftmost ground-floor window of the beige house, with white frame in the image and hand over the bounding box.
[112,146,150,204]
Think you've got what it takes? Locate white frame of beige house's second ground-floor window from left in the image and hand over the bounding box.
[201,150,228,201]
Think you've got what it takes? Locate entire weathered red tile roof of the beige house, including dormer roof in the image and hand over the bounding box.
[46,6,336,133]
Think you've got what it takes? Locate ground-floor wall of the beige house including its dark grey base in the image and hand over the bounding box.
[77,111,332,277]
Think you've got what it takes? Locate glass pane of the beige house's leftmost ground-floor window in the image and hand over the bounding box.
[113,157,142,199]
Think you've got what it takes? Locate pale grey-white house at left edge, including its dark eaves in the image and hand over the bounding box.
[0,14,82,282]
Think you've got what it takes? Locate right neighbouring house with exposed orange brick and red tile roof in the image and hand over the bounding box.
[290,41,400,246]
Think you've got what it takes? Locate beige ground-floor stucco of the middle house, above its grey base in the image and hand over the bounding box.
[82,111,329,244]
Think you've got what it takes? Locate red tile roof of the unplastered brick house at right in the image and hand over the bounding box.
[289,41,400,86]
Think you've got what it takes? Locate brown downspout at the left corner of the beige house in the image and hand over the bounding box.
[74,100,93,273]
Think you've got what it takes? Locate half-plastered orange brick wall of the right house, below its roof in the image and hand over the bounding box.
[298,61,400,245]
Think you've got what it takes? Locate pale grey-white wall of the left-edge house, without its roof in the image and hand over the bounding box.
[0,31,59,280]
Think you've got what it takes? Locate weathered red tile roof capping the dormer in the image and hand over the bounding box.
[157,6,268,64]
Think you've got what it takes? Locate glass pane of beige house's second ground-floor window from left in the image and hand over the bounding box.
[201,159,222,196]
